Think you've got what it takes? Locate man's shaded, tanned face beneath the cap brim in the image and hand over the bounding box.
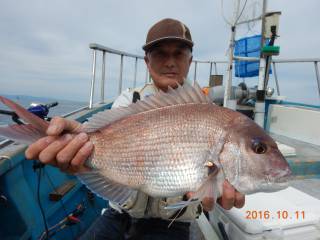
[145,41,192,91]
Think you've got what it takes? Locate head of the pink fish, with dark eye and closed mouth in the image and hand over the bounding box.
[219,116,291,194]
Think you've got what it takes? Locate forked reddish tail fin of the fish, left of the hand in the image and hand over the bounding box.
[0,96,49,143]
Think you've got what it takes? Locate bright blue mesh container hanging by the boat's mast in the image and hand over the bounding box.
[234,35,271,78]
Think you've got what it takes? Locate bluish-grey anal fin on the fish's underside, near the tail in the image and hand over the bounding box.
[77,170,136,205]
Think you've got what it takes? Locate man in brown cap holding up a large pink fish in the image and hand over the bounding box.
[26,19,244,239]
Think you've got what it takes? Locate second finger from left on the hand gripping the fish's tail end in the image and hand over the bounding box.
[39,134,73,164]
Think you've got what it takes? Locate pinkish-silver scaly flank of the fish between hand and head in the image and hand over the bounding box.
[90,104,225,195]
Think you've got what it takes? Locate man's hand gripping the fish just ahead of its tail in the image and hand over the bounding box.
[25,117,93,173]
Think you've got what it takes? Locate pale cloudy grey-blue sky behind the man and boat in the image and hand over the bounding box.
[0,0,320,105]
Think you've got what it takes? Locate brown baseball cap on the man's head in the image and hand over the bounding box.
[142,18,193,51]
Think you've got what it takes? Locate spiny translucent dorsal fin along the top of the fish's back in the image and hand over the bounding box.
[83,84,211,132]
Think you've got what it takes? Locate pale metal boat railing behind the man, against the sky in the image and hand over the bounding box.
[89,43,320,108]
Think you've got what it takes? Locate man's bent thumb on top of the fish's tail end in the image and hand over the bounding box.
[47,117,81,136]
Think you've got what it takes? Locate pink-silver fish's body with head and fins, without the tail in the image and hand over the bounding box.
[0,86,291,206]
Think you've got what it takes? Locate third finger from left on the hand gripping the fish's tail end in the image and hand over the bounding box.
[57,133,88,170]
